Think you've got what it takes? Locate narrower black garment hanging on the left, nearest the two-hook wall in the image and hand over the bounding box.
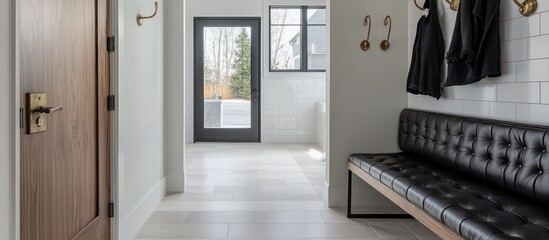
[406,0,445,99]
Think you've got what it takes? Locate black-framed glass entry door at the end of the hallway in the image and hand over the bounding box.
[194,18,260,142]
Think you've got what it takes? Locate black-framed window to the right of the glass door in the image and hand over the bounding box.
[269,6,326,72]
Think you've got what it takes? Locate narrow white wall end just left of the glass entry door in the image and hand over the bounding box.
[162,0,185,192]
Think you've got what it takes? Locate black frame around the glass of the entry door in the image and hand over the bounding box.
[192,17,262,142]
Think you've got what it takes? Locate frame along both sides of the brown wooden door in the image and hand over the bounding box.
[12,0,114,240]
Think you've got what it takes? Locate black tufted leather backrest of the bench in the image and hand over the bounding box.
[398,109,549,203]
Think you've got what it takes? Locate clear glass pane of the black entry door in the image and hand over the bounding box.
[203,27,252,128]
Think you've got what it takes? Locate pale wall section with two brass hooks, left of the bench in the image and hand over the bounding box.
[328,0,408,207]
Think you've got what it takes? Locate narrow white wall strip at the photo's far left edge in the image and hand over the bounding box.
[0,0,15,239]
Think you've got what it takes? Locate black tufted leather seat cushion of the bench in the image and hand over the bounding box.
[349,154,549,240]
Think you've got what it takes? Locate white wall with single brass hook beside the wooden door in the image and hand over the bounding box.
[117,0,166,240]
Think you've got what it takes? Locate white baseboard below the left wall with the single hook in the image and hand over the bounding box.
[119,177,166,240]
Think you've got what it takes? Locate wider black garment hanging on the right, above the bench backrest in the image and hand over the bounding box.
[444,0,501,87]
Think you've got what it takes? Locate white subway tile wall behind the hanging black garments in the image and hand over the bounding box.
[408,0,549,126]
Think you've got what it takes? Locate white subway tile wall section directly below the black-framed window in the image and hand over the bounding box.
[261,73,326,143]
